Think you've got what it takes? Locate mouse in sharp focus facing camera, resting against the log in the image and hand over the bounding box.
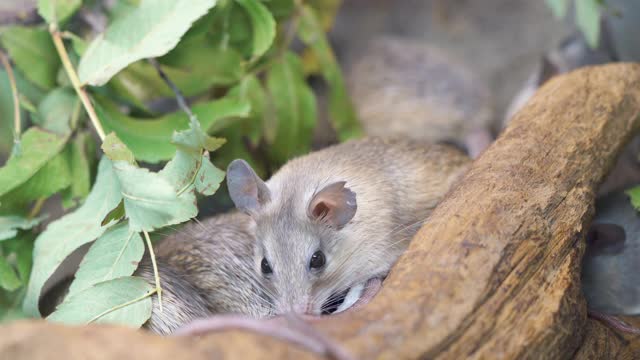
[227,137,471,315]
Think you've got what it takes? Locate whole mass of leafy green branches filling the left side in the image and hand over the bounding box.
[0,0,359,326]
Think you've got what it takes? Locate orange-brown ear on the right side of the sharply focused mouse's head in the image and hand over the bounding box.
[307,181,358,229]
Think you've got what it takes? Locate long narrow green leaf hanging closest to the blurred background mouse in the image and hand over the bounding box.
[300,6,363,141]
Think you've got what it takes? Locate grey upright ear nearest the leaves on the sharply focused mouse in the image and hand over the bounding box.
[227,159,271,213]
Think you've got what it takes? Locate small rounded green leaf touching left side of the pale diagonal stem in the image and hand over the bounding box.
[37,88,80,135]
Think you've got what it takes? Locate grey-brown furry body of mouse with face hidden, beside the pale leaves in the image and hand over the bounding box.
[134,211,272,335]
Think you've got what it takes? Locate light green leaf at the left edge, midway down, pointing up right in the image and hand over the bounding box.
[0,127,66,196]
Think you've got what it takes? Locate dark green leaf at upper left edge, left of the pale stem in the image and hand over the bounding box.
[0,26,60,90]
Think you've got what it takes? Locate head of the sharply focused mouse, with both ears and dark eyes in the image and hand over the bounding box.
[227,160,357,314]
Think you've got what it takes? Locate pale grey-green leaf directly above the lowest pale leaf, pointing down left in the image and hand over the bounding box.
[67,222,144,296]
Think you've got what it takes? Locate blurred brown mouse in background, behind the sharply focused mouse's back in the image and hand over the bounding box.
[347,36,494,158]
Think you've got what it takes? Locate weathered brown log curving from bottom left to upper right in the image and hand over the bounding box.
[0,64,640,360]
